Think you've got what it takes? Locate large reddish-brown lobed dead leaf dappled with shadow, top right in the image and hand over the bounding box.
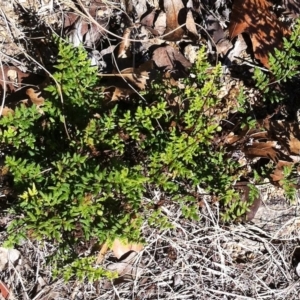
[229,0,289,68]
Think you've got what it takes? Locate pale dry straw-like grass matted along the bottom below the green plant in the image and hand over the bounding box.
[1,189,300,300]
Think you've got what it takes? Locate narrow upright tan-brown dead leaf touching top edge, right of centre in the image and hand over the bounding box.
[164,0,186,41]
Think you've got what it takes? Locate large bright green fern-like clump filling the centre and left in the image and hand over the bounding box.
[0,42,248,280]
